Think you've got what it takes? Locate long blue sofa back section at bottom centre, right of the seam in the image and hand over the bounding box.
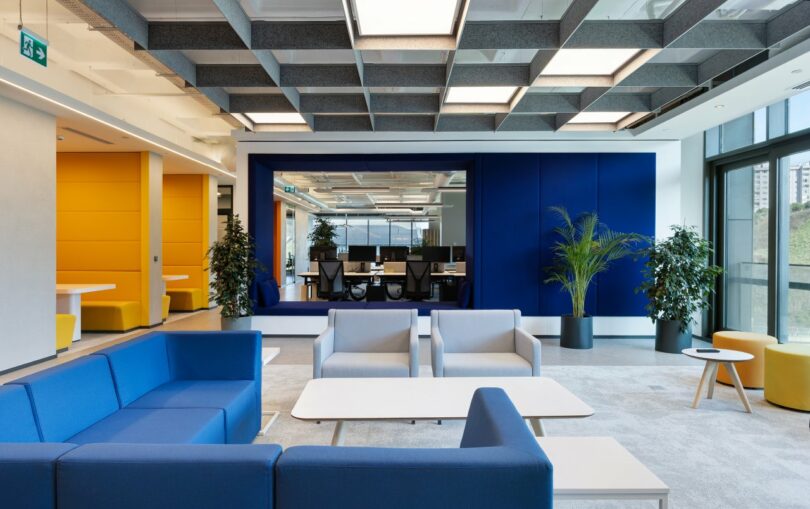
[276,446,552,509]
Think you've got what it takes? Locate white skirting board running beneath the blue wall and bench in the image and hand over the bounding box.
[251,316,655,337]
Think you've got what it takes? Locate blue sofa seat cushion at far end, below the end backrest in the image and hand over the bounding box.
[127,380,261,444]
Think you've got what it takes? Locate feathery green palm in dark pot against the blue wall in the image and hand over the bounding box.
[545,207,643,349]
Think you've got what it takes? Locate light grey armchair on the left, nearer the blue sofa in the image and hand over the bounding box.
[312,309,419,378]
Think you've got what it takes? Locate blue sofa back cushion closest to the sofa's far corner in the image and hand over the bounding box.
[93,334,171,407]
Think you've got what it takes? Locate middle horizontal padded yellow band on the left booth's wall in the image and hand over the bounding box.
[56,211,141,241]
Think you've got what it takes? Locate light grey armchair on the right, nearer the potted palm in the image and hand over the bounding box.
[430,309,540,377]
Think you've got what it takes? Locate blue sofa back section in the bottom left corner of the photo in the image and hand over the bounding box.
[0,443,76,507]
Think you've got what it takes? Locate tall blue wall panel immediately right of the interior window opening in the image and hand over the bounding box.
[475,154,542,315]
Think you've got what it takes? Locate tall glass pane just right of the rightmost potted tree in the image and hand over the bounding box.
[724,162,770,333]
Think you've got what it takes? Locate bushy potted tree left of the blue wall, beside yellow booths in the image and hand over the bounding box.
[208,214,259,330]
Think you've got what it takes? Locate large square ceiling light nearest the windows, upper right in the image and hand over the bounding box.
[540,49,639,76]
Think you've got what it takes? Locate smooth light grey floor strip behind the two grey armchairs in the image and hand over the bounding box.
[264,337,708,366]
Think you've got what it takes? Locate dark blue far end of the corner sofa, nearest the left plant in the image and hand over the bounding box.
[165,331,262,384]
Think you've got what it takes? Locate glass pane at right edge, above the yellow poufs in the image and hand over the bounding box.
[780,151,810,342]
